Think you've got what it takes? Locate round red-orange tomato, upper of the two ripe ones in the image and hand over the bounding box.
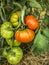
[25,15,39,30]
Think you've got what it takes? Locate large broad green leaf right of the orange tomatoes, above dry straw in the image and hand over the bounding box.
[31,30,49,54]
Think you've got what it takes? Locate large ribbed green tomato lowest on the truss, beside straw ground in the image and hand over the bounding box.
[7,47,23,64]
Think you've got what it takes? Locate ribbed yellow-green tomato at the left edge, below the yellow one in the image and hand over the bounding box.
[1,22,14,38]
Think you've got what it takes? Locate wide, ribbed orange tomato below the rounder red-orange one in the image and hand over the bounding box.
[15,29,35,43]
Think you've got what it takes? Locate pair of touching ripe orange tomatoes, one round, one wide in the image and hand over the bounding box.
[15,15,39,43]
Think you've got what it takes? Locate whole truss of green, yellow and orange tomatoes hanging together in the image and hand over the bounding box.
[1,11,39,64]
